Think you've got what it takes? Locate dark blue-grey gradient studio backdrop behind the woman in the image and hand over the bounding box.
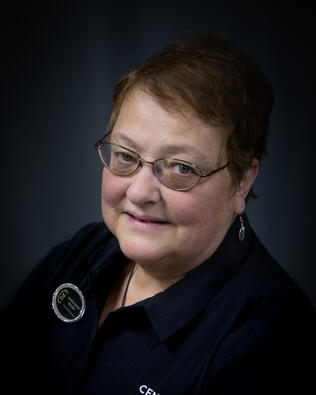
[0,0,316,308]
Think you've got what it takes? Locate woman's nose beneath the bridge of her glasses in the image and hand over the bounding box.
[126,164,161,206]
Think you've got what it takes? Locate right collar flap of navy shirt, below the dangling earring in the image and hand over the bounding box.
[144,215,252,341]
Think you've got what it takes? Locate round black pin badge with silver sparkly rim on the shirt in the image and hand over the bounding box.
[52,283,86,323]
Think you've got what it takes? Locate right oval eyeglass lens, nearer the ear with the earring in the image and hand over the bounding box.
[155,159,200,191]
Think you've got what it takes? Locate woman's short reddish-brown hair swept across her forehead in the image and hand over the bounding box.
[107,35,273,196]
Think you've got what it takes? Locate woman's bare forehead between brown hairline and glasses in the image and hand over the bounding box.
[111,89,225,159]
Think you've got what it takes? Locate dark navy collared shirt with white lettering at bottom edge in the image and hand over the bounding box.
[1,218,316,395]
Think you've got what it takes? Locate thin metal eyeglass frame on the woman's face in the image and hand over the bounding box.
[94,135,232,192]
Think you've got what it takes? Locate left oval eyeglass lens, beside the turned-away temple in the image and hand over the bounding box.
[99,143,139,175]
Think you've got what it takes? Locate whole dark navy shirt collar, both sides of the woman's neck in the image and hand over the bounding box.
[82,214,253,341]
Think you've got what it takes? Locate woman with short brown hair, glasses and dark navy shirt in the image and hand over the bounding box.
[2,36,316,394]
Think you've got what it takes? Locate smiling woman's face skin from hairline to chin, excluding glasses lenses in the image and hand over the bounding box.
[102,90,242,274]
